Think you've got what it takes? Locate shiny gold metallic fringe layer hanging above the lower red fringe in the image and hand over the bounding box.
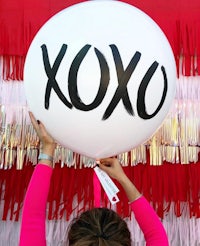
[0,102,200,169]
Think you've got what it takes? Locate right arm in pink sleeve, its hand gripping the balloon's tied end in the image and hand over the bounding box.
[99,158,168,246]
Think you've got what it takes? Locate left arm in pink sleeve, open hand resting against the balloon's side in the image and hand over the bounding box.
[19,113,55,246]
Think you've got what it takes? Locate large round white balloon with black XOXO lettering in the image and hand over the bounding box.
[24,1,176,158]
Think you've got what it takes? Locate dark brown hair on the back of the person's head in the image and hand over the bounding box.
[68,208,131,246]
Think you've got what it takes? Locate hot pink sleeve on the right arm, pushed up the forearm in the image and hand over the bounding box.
[131,196,169,246]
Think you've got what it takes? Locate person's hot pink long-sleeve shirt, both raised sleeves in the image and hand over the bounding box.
[19,164,168,246]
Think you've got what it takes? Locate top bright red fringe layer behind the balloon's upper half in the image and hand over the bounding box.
[0,0,200,80]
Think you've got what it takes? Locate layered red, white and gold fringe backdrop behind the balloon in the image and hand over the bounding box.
[0,0,200,246]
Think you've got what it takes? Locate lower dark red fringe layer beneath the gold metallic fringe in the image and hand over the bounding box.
[0,162,200,220]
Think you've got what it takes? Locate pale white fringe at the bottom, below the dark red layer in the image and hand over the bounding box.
[0,200,200,246]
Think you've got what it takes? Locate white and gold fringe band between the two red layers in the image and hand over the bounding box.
[0,76,200,169]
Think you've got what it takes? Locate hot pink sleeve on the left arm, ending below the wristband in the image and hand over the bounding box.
[19,164,53,246]
